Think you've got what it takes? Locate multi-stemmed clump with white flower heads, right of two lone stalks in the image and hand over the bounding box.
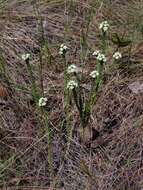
[59,18,122,140]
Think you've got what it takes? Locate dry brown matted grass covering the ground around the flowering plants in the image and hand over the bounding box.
[0,0,143,190]
